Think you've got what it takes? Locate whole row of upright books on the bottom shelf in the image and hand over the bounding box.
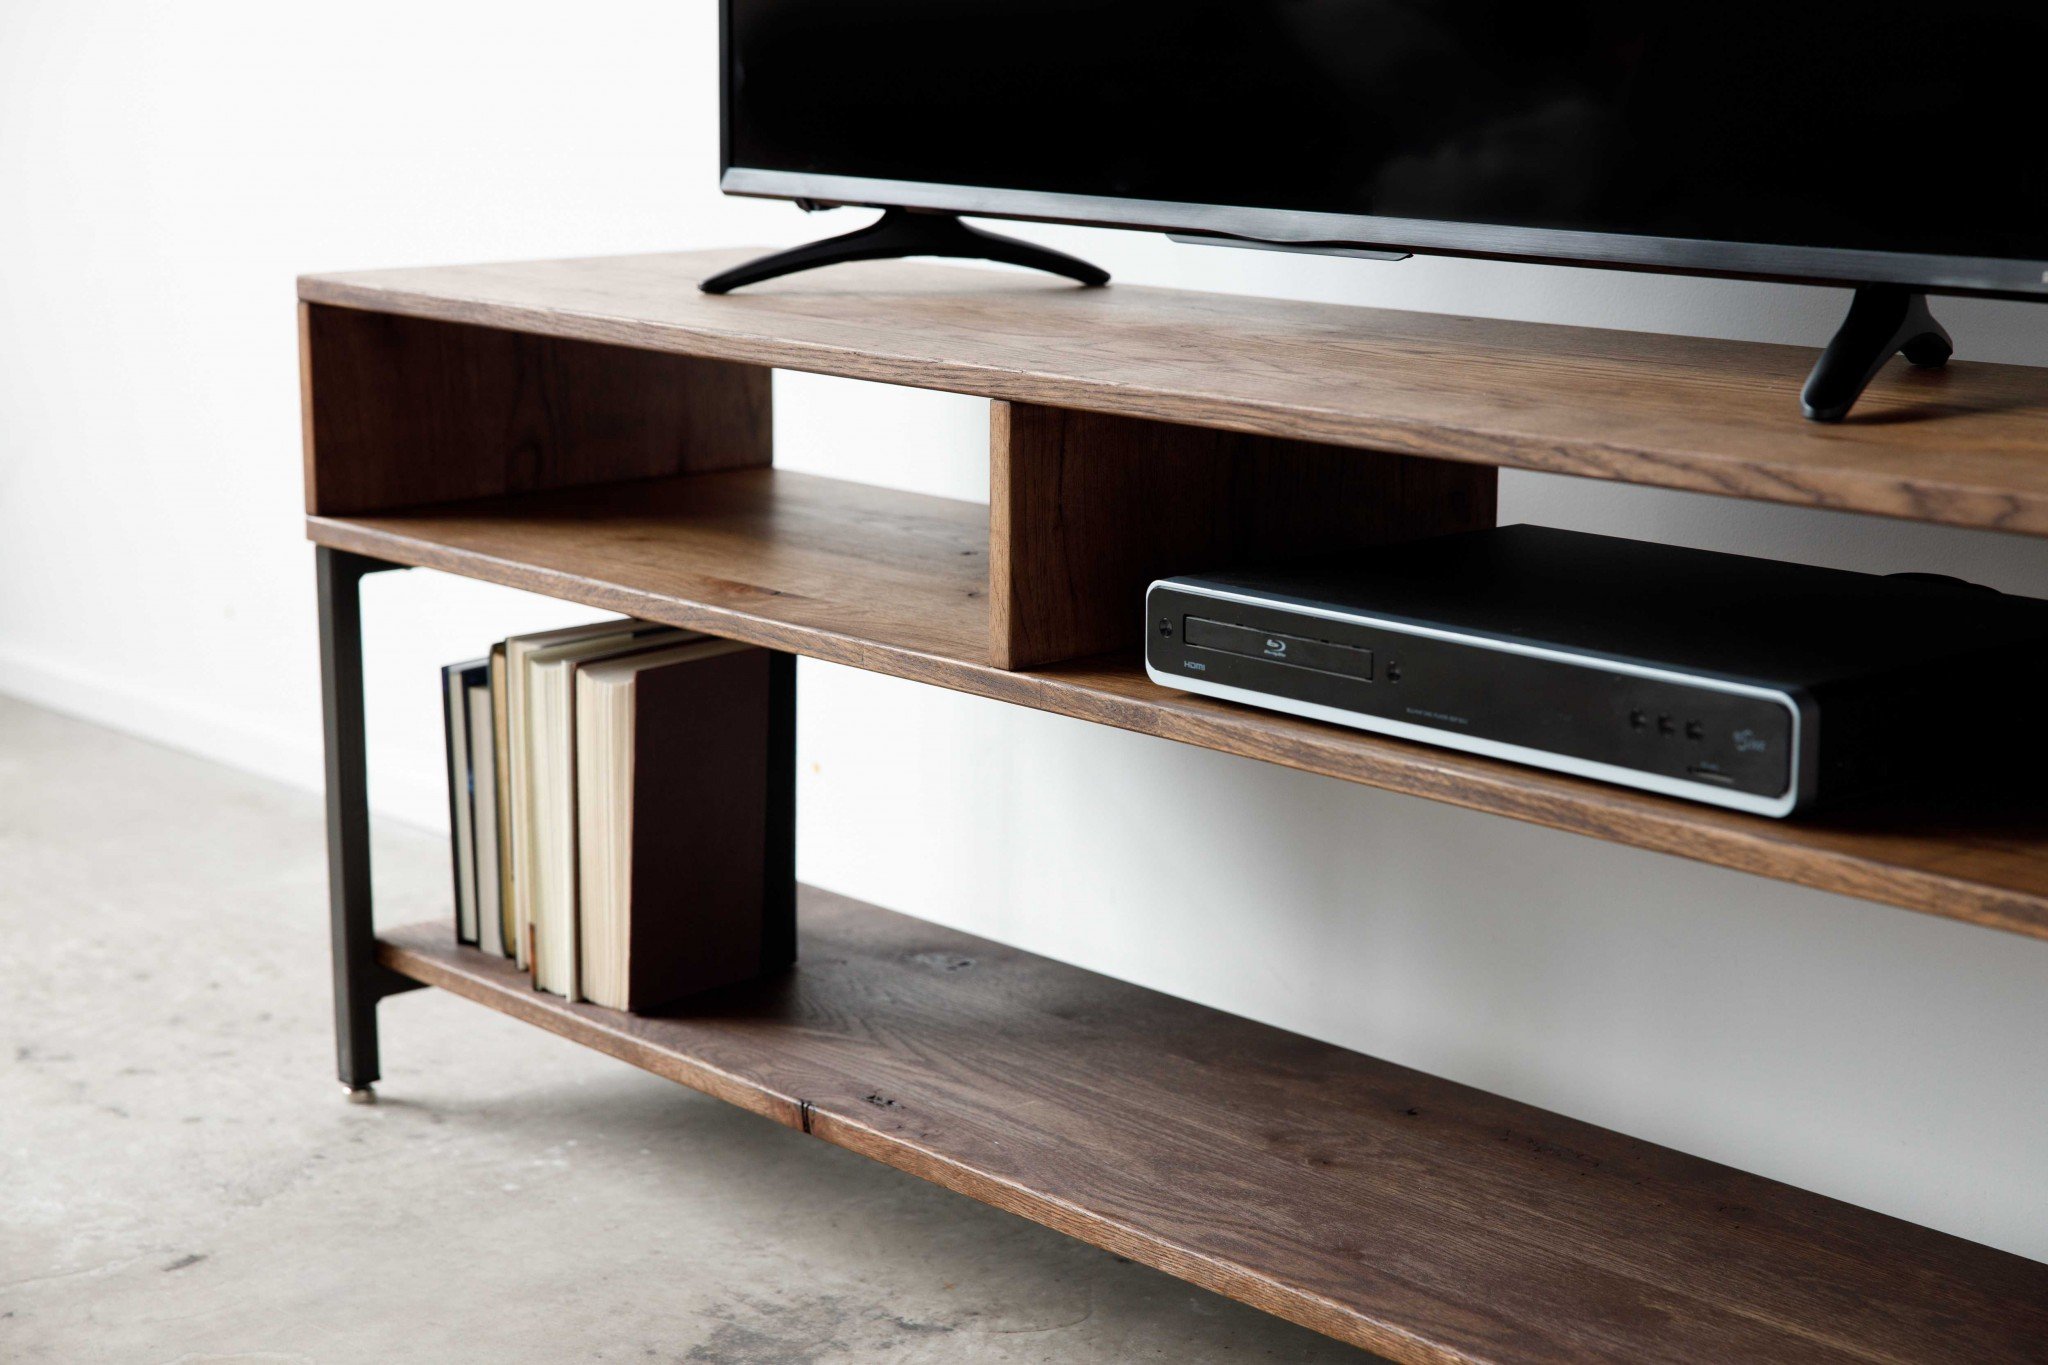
[442,618,778,1011]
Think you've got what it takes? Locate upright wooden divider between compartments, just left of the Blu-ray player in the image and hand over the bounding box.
[989,401,1495,669]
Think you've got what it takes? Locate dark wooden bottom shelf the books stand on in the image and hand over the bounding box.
[379,888,2048,1365]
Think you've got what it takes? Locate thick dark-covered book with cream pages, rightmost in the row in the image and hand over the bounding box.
[575,641,772,1011]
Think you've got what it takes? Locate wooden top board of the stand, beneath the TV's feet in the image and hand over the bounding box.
[299,250,2048,536]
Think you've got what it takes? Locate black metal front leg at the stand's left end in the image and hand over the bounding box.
[315,546,420,1103]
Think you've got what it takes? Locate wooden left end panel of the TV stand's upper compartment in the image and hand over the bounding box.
[299,303,772,516]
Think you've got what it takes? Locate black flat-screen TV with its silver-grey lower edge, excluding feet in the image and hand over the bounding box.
[725,0,2048,295]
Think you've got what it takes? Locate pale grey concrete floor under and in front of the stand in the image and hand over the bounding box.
[0,700,1368,1365]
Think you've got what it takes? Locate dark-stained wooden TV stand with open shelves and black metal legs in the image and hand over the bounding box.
[299,252,2048,1365]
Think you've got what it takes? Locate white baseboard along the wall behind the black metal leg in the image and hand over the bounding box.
[0,647,449,831]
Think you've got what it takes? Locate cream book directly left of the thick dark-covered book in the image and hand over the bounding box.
[514,626,698,1001]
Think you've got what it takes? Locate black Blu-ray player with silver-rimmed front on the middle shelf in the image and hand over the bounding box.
[1145,526,2048,817]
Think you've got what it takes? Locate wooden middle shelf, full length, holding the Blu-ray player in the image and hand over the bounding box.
[307,469,2048,937]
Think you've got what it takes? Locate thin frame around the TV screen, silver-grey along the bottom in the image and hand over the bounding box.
[719,0,2048,301]
